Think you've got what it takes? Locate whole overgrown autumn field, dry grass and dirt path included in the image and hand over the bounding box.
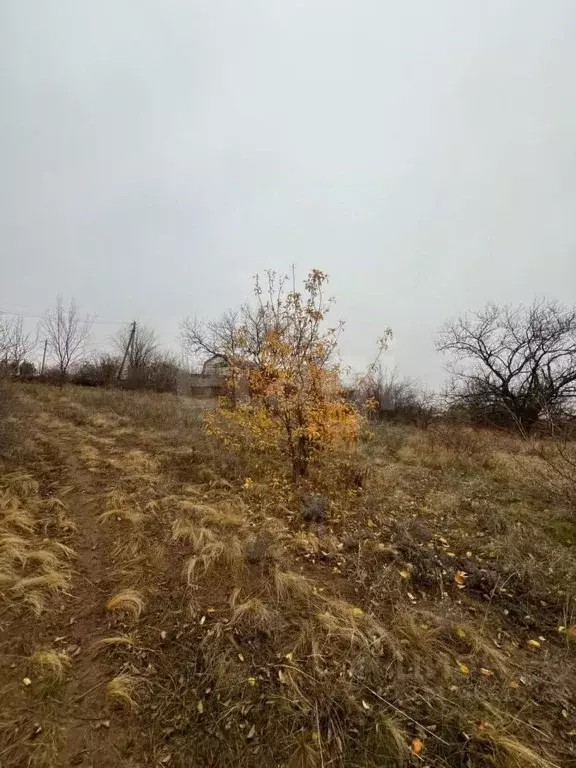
[0,385,576,768]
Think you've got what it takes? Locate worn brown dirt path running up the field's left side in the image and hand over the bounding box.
[0,400,145,768]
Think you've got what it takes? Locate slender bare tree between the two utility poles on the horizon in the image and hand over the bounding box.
[42,296,93,386]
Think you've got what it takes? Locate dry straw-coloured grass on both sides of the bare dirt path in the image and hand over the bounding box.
[0,380,576,768]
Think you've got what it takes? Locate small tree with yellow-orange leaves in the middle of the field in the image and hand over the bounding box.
[207,269,376,480]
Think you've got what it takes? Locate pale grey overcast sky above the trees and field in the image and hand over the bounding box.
[0,0,576,384]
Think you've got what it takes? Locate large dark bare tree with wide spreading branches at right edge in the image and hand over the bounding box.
[437,300,576,431]
